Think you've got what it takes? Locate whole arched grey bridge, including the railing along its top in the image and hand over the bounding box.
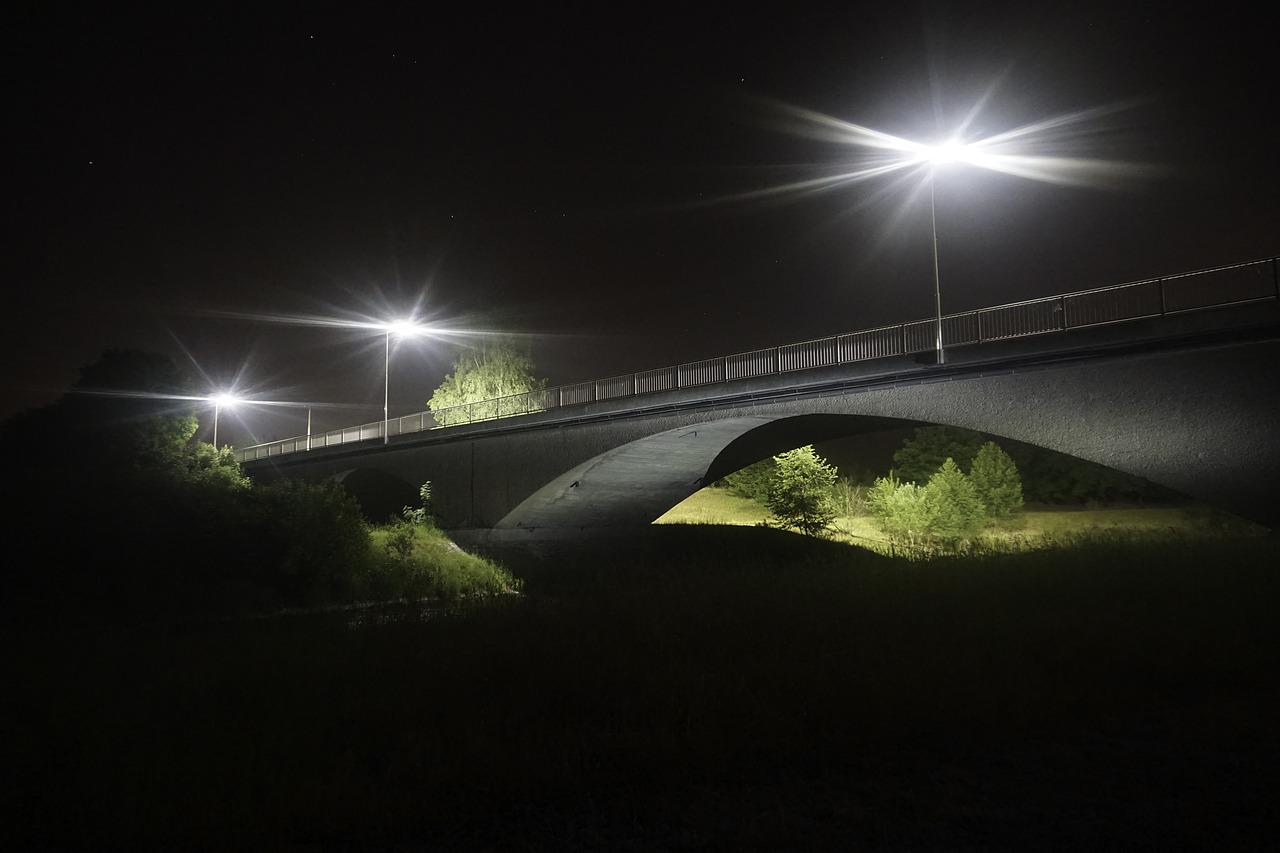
[238,259,1280,544]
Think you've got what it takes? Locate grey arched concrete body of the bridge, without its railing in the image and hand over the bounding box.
[246,306,1280,544]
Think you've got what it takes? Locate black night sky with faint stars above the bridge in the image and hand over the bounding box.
[0,1,1280,443]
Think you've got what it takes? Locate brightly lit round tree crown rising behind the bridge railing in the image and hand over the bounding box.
[426,342,547,427]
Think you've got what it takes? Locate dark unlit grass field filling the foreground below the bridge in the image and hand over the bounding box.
[3,528,1280,850]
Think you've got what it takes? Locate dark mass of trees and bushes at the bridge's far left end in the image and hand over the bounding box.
[0,350,369,619]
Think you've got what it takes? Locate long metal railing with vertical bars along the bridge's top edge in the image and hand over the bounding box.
[236,257,1280,462]
